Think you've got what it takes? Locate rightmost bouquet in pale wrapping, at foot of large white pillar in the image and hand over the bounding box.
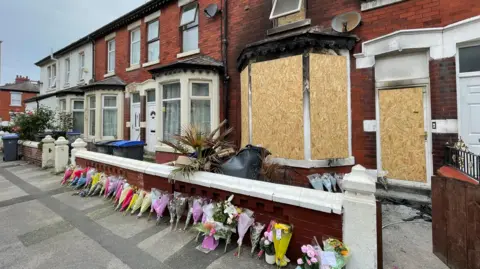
[322,238,350,269]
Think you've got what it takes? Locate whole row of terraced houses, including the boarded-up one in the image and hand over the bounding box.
[27,0,480,187]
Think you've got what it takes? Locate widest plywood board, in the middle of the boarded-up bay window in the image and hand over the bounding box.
[251,56,304,160]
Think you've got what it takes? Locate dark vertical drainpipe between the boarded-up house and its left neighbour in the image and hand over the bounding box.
[222,0,230,128]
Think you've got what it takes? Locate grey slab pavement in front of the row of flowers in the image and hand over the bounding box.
[0,161,275,269]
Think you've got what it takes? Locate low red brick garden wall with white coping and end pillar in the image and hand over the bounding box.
[75,151,377,269]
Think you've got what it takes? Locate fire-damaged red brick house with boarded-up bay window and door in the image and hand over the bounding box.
[228,0,480,188]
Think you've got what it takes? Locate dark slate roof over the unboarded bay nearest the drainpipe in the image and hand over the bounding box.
[148,55,223,74]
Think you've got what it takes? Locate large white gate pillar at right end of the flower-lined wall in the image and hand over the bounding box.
[343,165,377,269]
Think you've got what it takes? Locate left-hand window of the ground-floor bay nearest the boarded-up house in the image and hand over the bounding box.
[162,83,181,142]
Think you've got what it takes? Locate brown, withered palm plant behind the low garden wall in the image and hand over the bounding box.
[162,120,235,179]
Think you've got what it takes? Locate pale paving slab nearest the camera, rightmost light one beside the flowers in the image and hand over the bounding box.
[137,226,196,262]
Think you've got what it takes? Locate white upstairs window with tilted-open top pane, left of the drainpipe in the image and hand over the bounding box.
[180,2,199,52]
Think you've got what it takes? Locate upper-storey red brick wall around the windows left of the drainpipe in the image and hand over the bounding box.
[95,0,221,82]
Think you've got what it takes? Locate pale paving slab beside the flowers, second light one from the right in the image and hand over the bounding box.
[96,210,155,238]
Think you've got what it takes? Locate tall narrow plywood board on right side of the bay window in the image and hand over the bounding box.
[310,53,349,160]
